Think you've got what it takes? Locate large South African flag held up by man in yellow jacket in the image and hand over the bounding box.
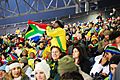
[25,20,47,42]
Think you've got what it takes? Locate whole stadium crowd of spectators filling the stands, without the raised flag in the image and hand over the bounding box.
[0,8,120,80]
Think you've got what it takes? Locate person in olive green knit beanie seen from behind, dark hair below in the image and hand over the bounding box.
[58,55,84,80]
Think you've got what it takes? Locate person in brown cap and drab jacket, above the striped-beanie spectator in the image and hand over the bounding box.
[97,30,111,54]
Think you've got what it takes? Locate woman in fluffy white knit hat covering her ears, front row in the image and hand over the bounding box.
[34,60,50,80]
